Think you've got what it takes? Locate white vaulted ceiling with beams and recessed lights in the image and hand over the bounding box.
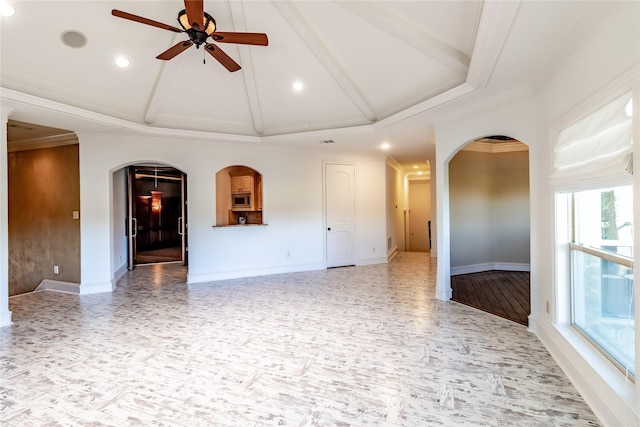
[0,0,607,174]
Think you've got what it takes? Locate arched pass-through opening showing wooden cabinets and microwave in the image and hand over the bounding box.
[216,165,264,227]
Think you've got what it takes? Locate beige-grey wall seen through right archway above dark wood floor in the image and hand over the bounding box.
[449,150,530,268]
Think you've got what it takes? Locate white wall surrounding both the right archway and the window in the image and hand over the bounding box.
[435,2,640,426]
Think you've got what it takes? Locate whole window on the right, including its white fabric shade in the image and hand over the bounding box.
[551,92,637,377]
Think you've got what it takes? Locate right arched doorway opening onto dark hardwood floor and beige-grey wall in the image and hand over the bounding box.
[449,135,531,325]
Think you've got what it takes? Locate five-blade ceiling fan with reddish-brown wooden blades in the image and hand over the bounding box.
[111,0,269,72]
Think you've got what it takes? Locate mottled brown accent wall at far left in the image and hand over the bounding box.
[8,144,80,295]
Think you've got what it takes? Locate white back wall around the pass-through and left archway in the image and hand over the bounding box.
[78,132,386,293]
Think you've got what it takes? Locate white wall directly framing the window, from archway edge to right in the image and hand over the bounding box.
[531,2,640,425]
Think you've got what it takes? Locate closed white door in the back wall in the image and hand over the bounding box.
[324,163,356,267]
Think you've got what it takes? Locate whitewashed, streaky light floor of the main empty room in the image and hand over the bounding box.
[0,253,599,426]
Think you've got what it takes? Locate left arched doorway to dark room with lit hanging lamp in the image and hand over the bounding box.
[127,163,188,270]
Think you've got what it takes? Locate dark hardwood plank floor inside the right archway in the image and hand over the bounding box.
[451,270,531,326]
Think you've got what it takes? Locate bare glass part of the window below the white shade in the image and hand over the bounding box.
[569,185,635,376]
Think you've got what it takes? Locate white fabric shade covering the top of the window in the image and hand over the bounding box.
[551,92,633,191]
